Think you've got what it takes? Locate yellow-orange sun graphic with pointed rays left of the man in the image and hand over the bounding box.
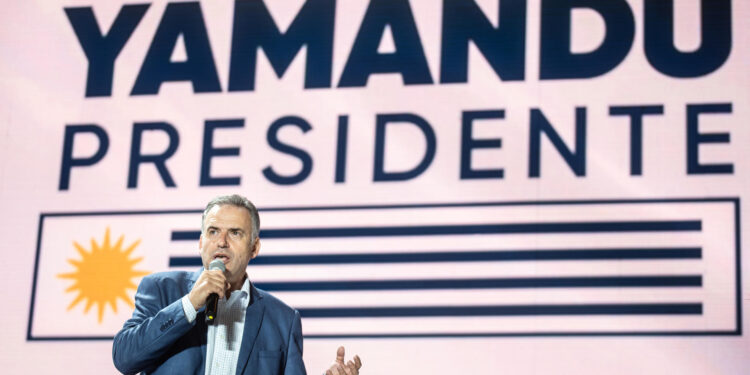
[57,227,149,324]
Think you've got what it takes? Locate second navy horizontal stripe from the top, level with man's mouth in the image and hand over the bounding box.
[169,247,702,267]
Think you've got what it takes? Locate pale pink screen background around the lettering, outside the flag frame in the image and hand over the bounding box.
[0,0,750,374]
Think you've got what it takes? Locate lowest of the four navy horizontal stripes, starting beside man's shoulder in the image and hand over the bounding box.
[297,303,703,318]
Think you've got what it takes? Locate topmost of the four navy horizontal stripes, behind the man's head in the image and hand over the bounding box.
[172,220,701,241]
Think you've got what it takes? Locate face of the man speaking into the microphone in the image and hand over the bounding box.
[198,205,260,286]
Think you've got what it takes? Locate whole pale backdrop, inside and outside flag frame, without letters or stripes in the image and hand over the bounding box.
[0,0,750,374]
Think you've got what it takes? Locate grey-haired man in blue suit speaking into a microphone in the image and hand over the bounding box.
[112,195,361,375]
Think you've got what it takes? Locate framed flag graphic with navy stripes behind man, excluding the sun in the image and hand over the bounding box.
[30,199,740,338]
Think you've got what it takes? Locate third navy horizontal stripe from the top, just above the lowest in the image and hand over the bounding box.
[255,275,703,292]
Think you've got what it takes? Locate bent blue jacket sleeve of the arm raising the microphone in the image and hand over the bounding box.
[112,276,195,374]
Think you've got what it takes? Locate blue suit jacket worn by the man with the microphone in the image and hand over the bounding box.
[112,271,305,375]
